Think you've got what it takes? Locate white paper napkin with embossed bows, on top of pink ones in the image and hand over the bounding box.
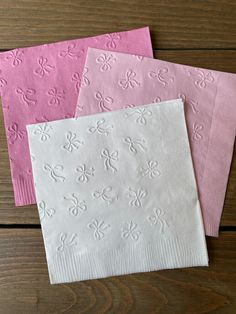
[27,100,208,283]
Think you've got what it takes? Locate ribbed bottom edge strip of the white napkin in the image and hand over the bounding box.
[48,233,208,284]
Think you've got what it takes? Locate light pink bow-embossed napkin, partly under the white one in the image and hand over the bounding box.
[76,49,236,236]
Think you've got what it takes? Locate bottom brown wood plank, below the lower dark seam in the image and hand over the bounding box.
[0,229,236,314]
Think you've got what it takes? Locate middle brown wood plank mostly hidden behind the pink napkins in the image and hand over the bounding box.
[0,50,236,226]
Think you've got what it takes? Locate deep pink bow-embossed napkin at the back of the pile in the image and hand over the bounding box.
[0,27,153,206]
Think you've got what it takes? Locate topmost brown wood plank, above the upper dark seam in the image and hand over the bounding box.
[0,0,236,49]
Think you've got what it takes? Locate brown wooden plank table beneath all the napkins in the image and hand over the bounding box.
[0,0,236,314]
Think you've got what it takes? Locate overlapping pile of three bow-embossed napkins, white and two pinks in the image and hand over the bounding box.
[0,27,236,283]
